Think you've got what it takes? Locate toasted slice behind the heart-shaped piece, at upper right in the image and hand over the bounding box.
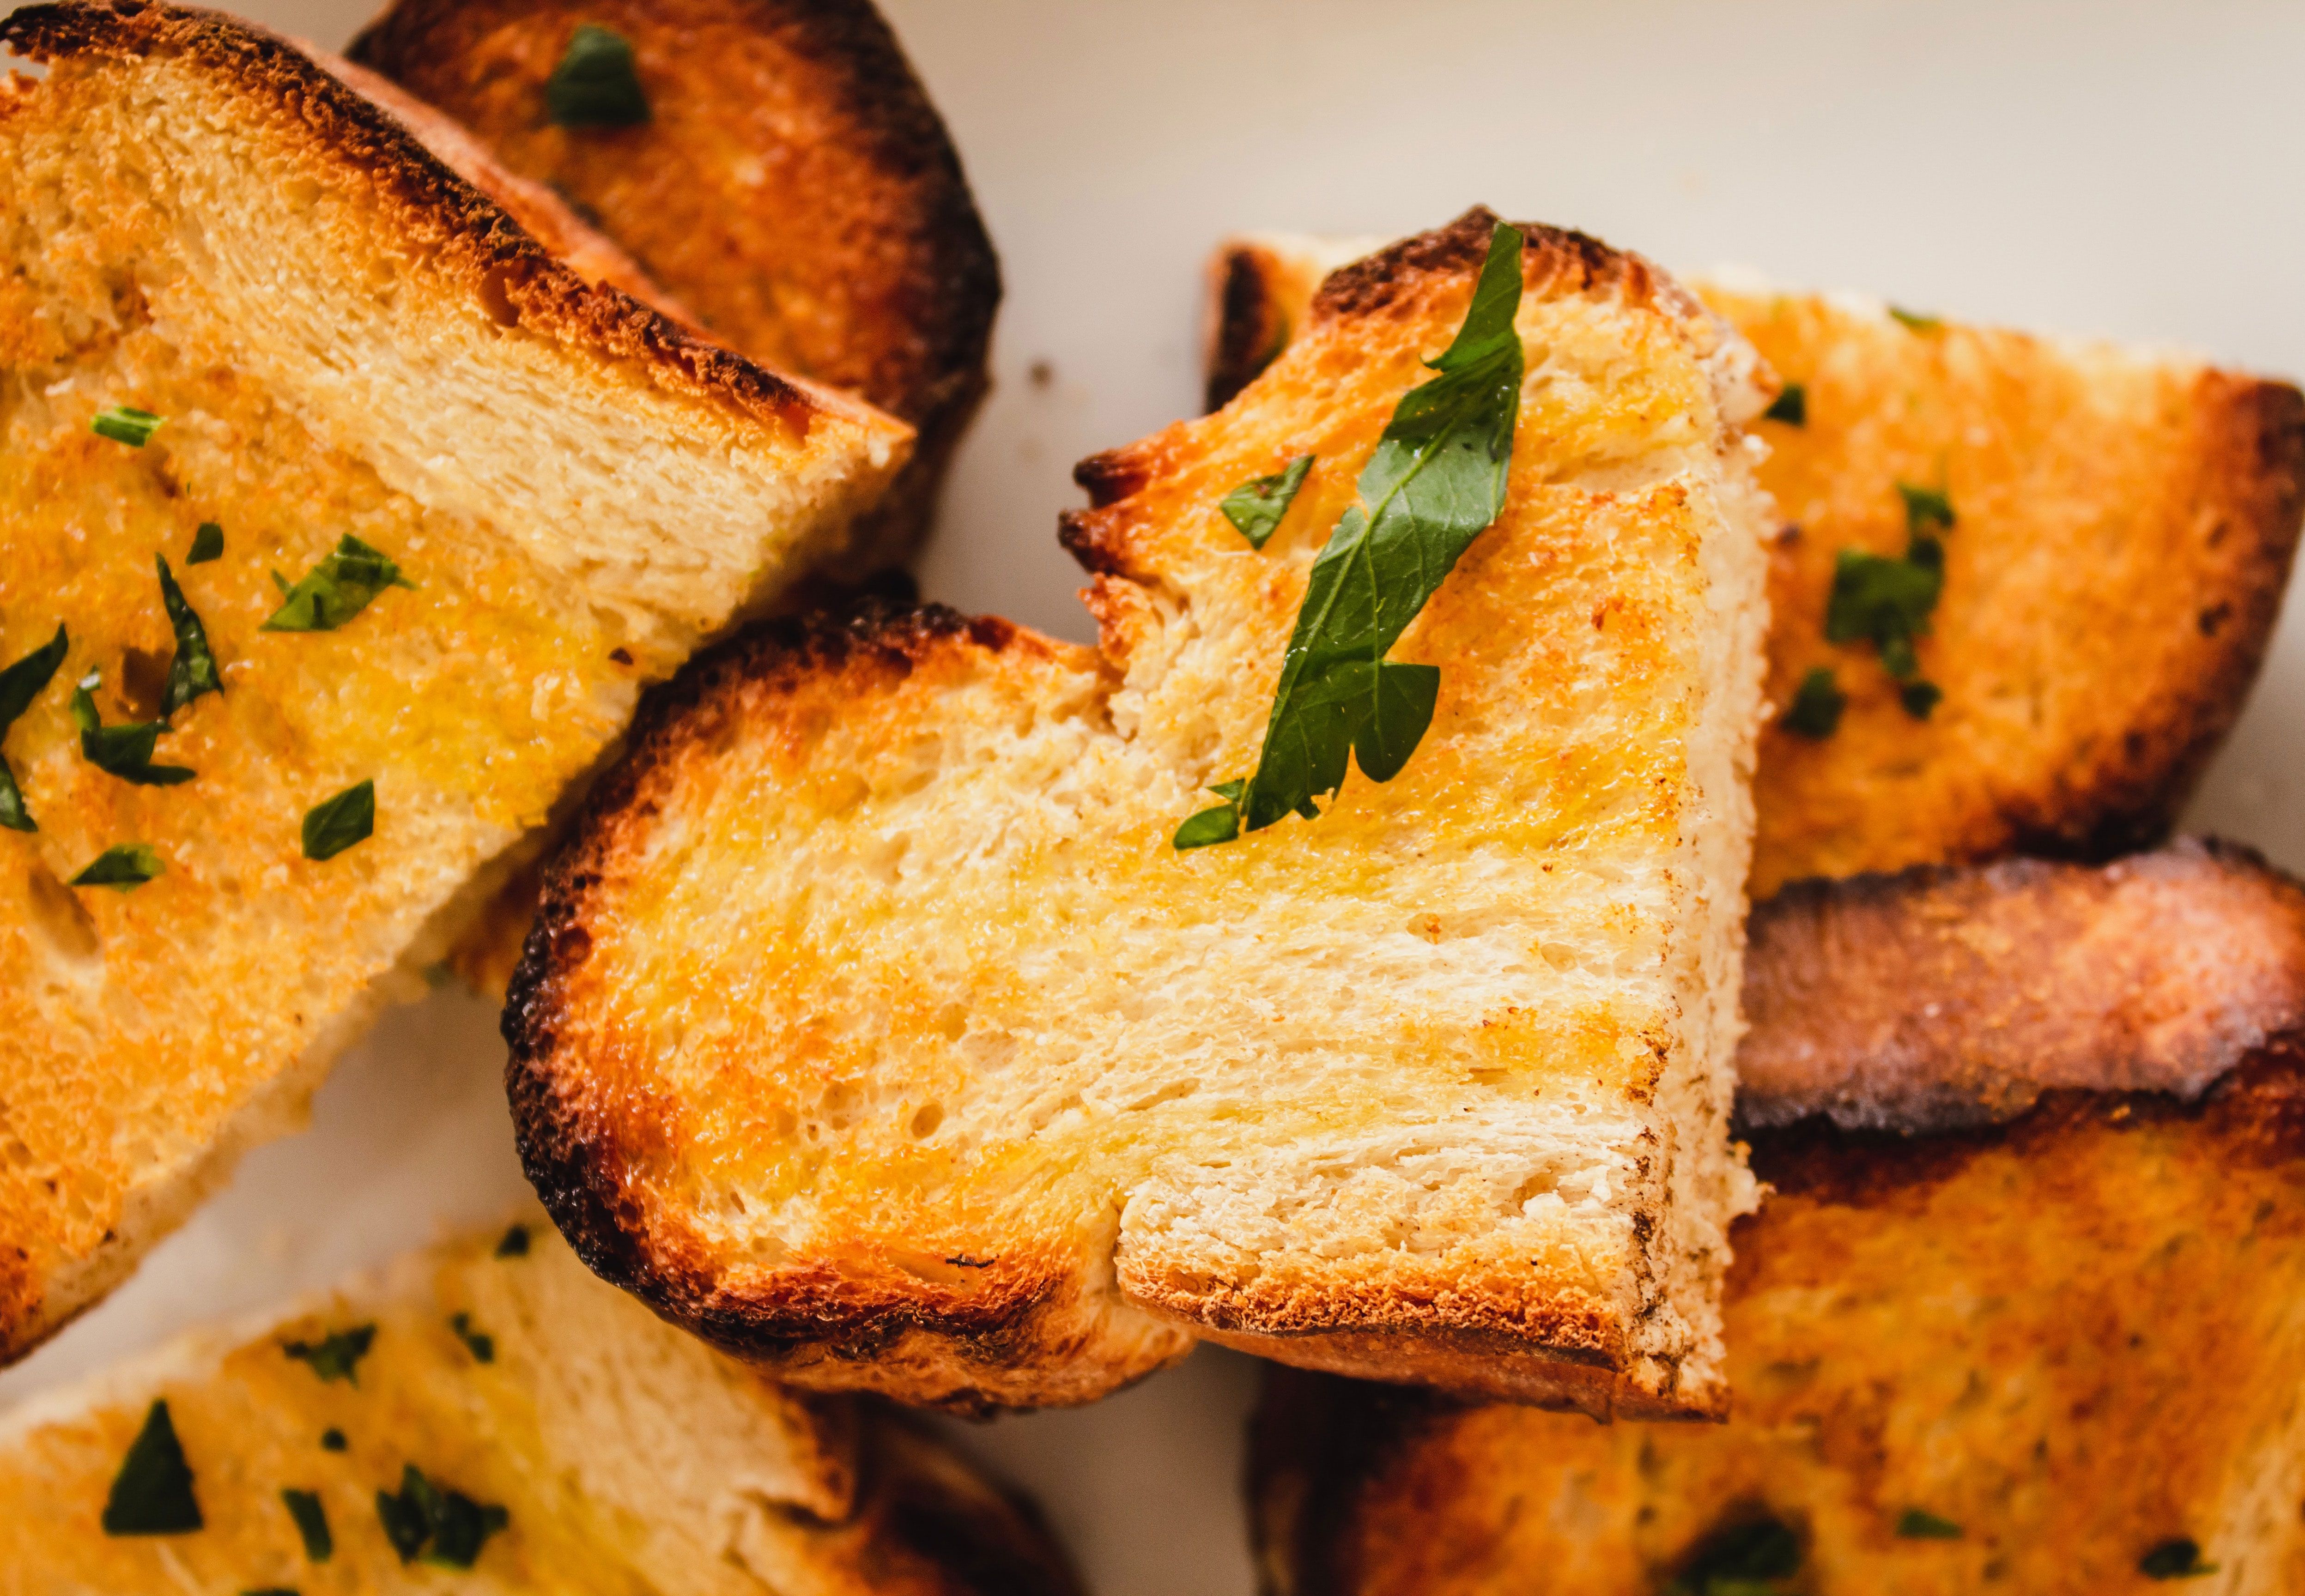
[1208,237,2305,896]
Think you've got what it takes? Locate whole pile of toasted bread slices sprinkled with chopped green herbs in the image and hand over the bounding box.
[13,0,2305,1596]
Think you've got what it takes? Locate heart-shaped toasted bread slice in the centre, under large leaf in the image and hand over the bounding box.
[505,212,1768,1414]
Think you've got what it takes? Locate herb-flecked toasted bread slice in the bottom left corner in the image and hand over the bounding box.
[0,1216,1076,1596]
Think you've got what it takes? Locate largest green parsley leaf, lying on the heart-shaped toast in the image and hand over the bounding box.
[1173,224,1521,847]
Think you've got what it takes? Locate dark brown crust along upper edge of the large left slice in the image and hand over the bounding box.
[0,0,890,438]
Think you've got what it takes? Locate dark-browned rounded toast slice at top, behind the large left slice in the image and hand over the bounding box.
[352,0,1001,576]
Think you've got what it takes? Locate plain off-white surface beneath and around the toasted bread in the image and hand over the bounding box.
[0,0,2305,1596]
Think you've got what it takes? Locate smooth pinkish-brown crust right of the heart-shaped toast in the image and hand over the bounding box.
[1738,840,2305,1133]
